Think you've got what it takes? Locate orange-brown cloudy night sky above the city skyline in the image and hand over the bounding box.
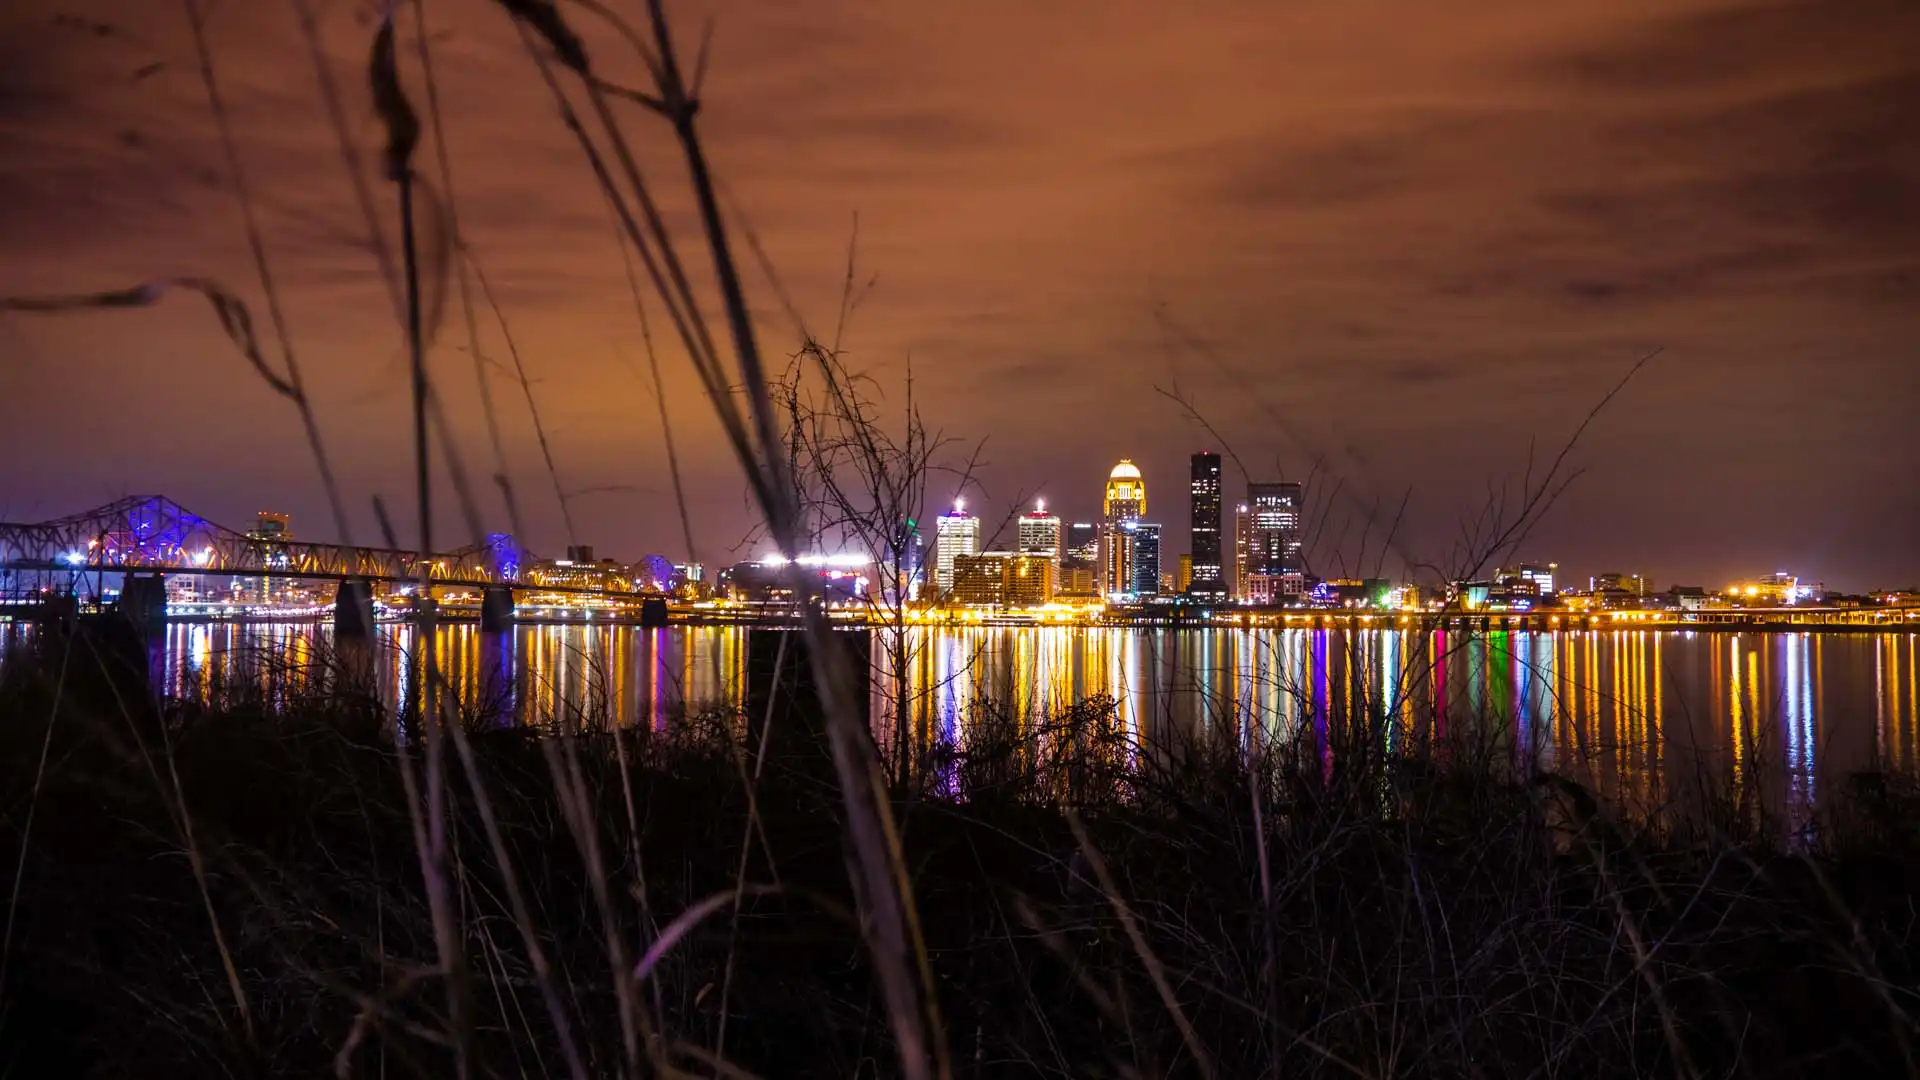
[0,0,1920,588]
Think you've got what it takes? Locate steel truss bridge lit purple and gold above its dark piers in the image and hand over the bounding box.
[0,496,541,592]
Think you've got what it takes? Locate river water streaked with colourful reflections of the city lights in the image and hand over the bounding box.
[6,623,1920,817]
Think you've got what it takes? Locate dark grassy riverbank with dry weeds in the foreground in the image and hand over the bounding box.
[0,630,1920,1078]
